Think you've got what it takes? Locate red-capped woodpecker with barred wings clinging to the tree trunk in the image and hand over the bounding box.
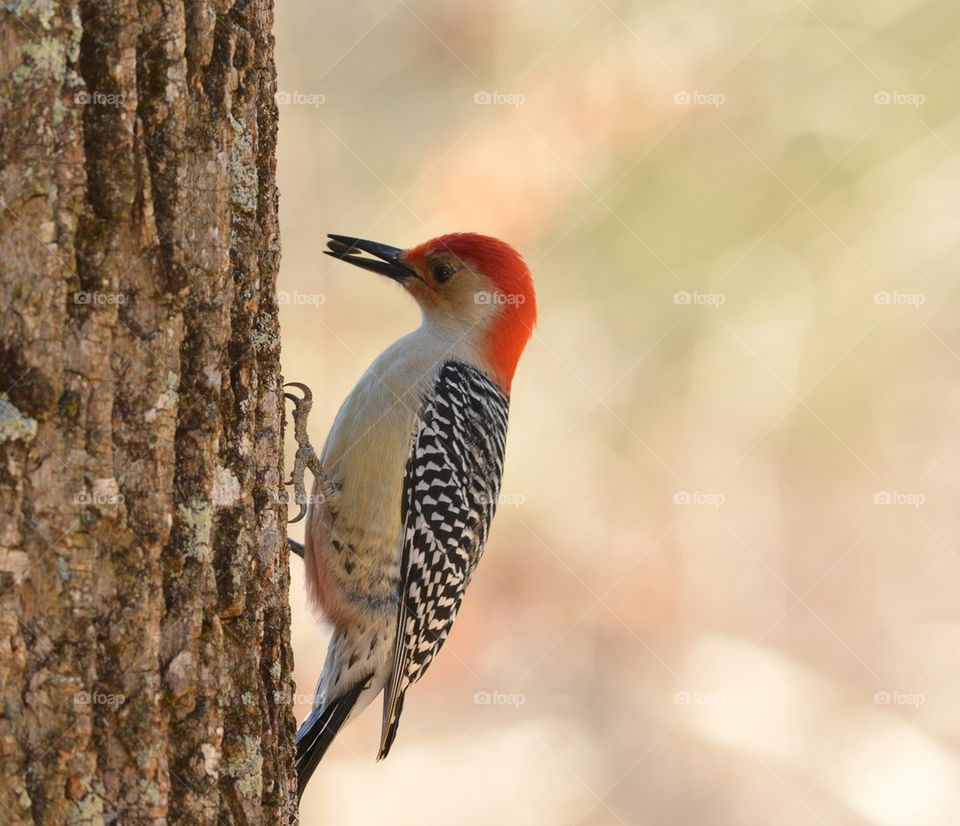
[290,233,537,795]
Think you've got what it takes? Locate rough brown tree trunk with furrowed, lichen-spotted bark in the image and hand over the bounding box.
[0,0,296,824]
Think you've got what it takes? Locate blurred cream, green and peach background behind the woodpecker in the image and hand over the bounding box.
[276,0,960,826]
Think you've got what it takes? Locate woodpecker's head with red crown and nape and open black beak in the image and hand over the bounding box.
[325,232,537,393]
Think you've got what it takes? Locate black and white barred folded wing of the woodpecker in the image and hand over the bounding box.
[380,361,509,757]
